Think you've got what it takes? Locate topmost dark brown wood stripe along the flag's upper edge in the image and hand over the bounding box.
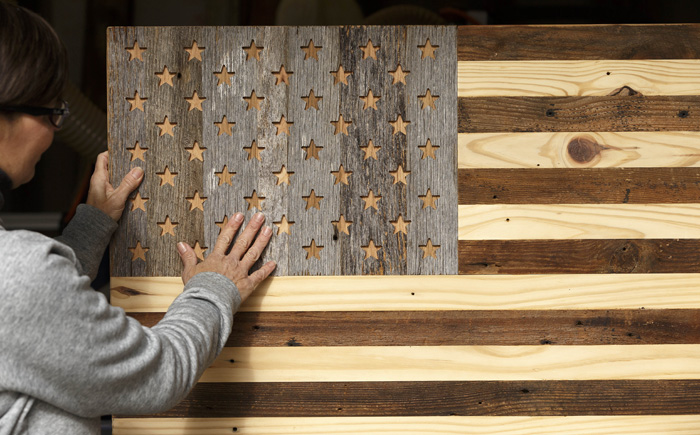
[457,24,700,61]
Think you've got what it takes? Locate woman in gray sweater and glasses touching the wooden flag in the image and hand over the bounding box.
[0,1,275,435]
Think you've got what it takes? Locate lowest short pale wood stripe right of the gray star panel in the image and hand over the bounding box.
[459,204,700,240]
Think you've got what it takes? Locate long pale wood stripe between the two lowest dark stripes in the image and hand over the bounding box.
[200,344,700,382]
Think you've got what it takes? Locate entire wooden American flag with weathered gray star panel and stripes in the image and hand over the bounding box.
[109,25,700,434]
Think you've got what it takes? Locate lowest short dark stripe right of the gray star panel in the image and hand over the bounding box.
[458,239,700,275]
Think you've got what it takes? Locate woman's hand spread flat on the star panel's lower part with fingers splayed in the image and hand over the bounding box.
[177,213,276,301]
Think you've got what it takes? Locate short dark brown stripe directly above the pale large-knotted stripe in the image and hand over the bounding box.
[457,96,700,133]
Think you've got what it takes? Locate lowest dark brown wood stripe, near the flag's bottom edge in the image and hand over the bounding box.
[131,380,700,418]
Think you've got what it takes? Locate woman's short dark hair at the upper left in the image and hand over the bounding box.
[0,0,68,106]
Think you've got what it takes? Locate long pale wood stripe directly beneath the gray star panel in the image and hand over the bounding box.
[111,273,700,312]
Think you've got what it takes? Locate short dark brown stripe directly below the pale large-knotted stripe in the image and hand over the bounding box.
[458,168,700,204]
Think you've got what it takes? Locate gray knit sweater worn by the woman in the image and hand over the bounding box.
[0,202,241,435]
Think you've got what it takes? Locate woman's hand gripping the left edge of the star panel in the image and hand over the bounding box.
[86,151,143,221]
